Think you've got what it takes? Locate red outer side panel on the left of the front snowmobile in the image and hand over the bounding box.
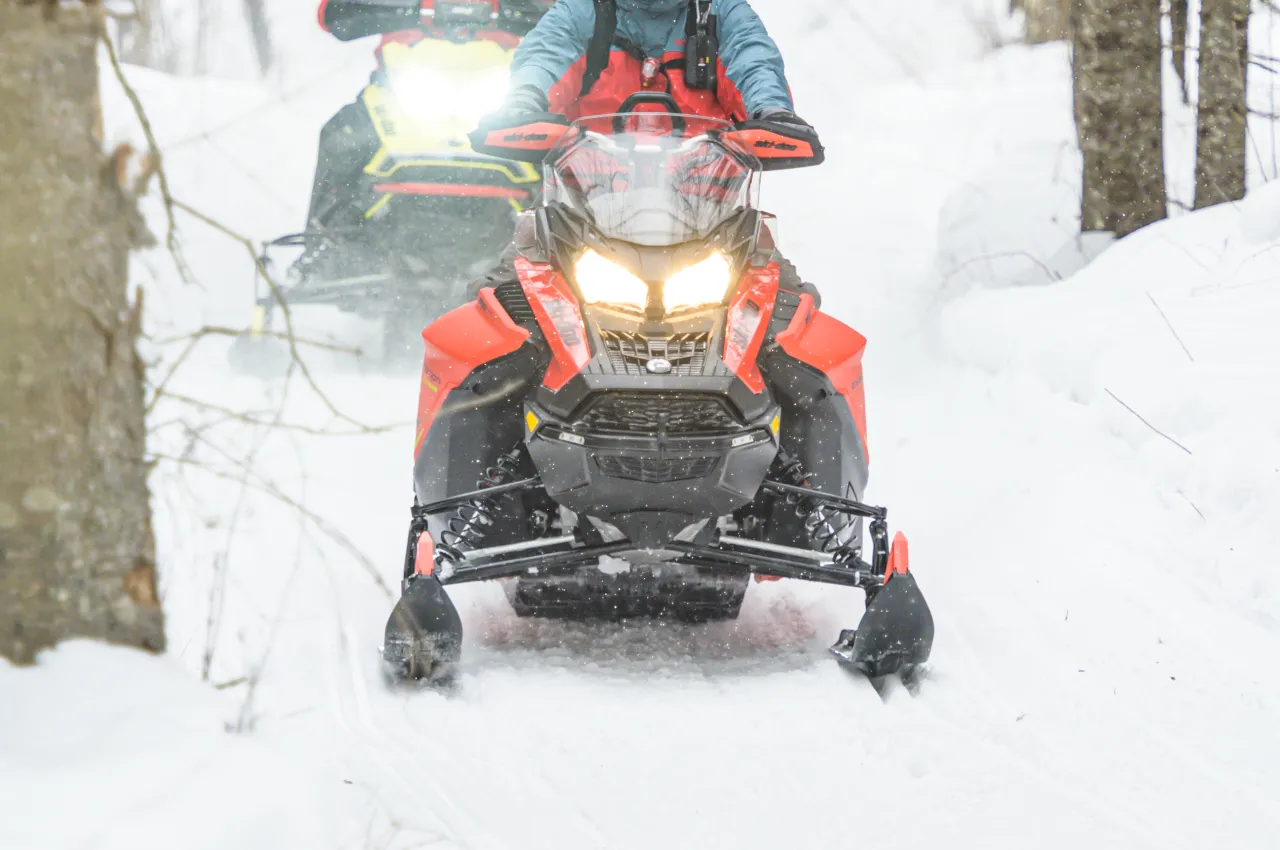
[413,288,529,457]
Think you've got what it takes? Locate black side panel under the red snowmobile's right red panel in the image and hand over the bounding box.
[762,348,868,547]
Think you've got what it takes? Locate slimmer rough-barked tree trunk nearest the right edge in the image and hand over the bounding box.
[1196,0,1249,210]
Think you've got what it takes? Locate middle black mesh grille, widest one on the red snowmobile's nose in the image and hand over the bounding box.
[579,393,741,434]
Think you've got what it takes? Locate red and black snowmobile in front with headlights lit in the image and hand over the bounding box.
[383,95,933,680]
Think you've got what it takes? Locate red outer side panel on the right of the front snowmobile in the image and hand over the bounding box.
[777,296,870,461]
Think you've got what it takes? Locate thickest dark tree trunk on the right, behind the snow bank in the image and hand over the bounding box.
[1071,0,1165,236]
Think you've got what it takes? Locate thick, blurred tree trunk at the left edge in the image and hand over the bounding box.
[0,0,164,663]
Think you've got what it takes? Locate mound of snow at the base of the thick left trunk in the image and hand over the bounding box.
[0,641,342,850]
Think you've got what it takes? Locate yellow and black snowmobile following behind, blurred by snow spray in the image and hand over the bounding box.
[232,38,541,371]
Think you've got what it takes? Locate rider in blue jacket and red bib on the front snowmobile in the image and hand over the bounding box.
[480,0,818,300]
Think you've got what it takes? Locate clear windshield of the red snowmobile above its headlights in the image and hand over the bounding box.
[543,113,760,247]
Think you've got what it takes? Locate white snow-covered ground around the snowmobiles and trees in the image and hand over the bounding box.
[0,0,1280,850]
